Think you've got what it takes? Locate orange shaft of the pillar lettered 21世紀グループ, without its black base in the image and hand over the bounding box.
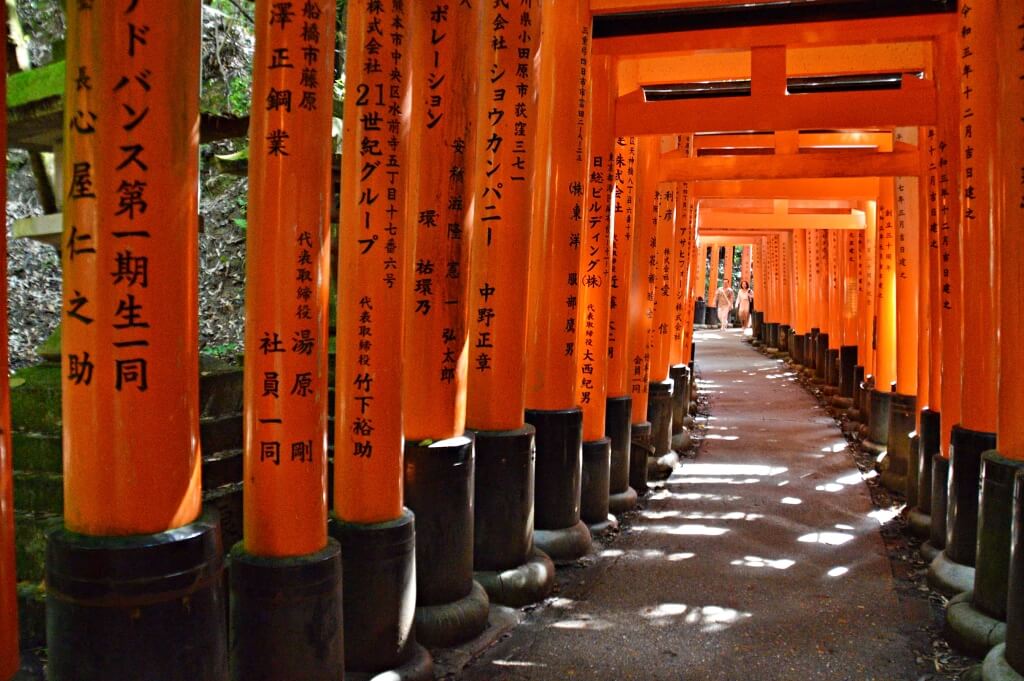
[335,0,409,522]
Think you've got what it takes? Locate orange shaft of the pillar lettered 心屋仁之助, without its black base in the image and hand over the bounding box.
[61,0,200,535]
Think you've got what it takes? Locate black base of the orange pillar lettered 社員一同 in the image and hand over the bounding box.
[230,539,345,681]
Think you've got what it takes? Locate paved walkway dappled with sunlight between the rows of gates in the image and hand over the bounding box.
[461,331,925,681]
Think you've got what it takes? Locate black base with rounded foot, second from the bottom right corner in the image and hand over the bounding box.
[945,450,1024,657]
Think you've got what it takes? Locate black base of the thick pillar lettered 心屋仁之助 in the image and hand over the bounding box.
[46,511,228,681]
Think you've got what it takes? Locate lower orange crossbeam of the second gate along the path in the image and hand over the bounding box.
[658,151,921,180]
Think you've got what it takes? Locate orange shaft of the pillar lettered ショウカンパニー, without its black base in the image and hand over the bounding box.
[466,0,541,430]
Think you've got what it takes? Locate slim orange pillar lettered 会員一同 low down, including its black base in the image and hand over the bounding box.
[629,136,658,494]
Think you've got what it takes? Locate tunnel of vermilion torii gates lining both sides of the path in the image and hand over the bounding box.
[0,0,1024,681]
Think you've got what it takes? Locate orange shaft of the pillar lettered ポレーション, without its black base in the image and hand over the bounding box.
[403,2,477,440]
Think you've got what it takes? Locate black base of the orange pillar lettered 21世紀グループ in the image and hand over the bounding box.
[328,509,433,681]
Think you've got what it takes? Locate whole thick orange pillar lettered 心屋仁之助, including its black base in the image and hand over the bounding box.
[46,0,227,681]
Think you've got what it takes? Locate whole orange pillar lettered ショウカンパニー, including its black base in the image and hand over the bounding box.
[463,3,554,606]
